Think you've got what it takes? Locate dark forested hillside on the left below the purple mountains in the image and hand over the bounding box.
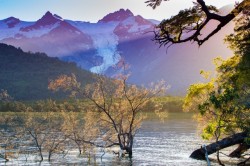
[0,44,94,100]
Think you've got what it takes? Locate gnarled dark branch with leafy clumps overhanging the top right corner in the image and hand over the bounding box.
[146,0,250,46]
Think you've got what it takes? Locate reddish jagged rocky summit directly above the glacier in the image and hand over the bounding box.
[98,9,134,23]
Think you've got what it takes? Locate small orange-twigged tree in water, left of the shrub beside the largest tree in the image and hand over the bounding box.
[22,100,68,161]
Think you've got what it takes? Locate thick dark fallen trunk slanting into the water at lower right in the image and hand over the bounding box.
[190,132,247,160]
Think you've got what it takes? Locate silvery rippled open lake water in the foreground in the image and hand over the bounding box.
[0,112,222,166]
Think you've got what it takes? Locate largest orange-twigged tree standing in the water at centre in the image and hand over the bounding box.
[49,72,165,157]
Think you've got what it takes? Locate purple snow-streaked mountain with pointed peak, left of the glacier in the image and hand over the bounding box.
[0,12,92,57]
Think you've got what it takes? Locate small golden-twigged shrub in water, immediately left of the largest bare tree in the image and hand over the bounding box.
[60,101,100,155]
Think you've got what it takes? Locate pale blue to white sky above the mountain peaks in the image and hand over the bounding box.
[0,0,235,22]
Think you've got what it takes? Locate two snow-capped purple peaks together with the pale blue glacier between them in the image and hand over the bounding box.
[0,9,153,73]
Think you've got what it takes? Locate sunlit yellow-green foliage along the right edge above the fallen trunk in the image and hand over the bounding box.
[184,14,250,141]
